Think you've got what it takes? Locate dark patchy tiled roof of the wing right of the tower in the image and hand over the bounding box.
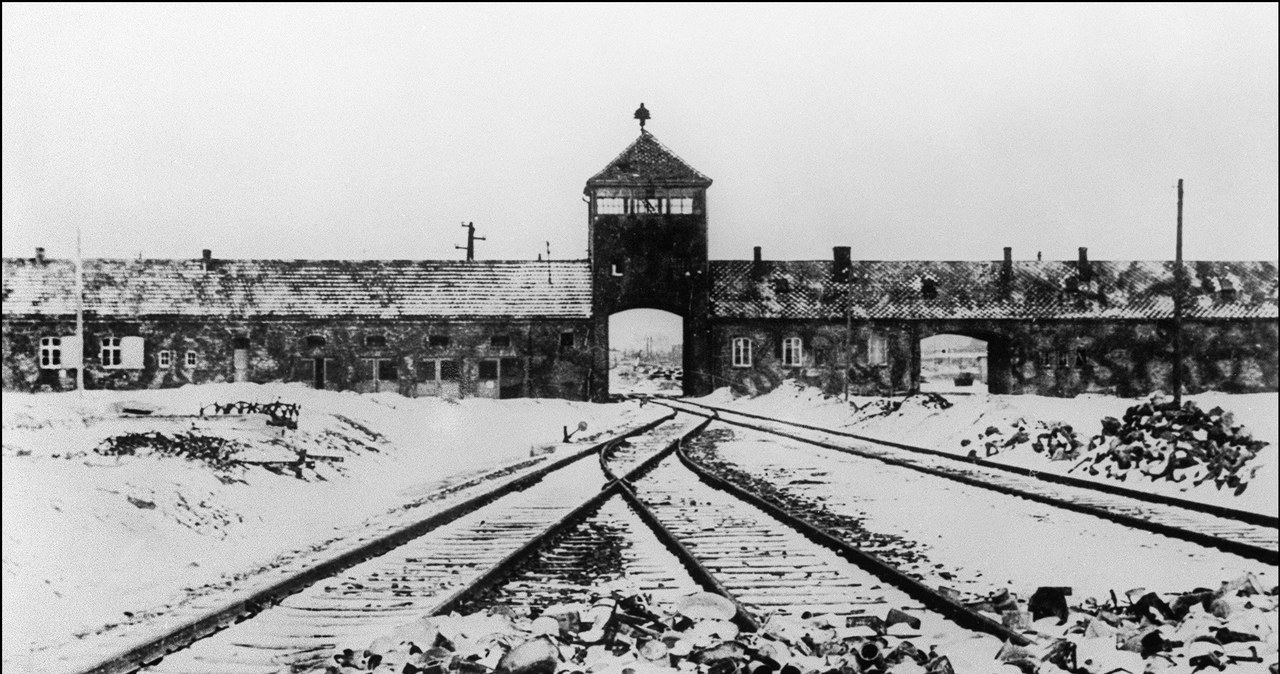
[710,261,1280,320]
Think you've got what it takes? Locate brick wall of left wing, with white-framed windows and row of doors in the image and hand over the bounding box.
[3,318,591,399]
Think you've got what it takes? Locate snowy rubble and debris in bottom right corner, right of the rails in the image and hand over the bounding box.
[969,574,1280,674]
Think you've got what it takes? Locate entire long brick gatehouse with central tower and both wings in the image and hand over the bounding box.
[3,115,1280,400]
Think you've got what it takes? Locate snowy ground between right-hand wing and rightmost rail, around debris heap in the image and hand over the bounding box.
[700,382,1280,515]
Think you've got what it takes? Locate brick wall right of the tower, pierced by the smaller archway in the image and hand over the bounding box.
[710,320,1277,396]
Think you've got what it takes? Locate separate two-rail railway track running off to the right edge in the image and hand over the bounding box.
[653,400,1280,565]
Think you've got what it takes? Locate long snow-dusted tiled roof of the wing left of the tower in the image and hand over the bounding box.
[3,258,591,318]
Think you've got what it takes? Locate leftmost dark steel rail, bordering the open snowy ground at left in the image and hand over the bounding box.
[84,412,676,674]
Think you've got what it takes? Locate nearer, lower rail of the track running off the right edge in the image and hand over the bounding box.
[653,400,1280,565]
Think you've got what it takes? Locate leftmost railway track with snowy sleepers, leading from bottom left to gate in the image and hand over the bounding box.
[80,413,696,673]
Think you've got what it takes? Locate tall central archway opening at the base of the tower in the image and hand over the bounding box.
[609,310,685,396]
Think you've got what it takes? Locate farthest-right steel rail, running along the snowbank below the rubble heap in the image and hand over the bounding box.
[665,399,1280,529]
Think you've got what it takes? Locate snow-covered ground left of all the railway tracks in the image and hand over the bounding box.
[3,384,664,668]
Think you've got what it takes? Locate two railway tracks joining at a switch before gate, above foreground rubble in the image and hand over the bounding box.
[91,403,1274,673]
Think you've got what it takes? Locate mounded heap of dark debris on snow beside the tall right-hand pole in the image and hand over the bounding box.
[1085,398,1267,495]
